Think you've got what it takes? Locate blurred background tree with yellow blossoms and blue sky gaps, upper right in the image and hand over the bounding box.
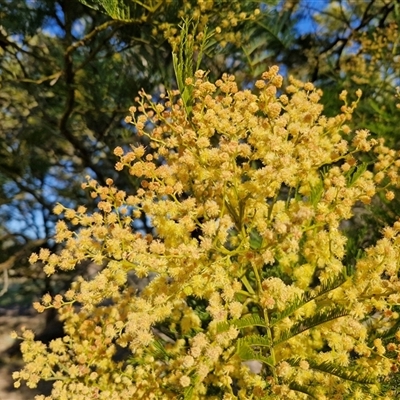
[284,0,400,247]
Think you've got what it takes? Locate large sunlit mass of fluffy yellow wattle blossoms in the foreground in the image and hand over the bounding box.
[14,67,400,400]
